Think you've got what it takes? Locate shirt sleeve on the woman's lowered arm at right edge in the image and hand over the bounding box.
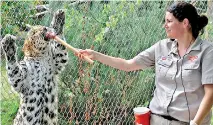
[201,47,213,84]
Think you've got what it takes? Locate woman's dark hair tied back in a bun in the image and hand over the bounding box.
[167,2,208,38]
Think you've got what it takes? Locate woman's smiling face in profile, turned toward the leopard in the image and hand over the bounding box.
[164,12,184,39]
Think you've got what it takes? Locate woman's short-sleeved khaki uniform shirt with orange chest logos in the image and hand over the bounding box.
[134,38,213,122]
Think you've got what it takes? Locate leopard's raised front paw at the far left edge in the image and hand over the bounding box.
[1,34,16,56]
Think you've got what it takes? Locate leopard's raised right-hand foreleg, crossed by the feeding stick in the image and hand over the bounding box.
[50,10,68,74]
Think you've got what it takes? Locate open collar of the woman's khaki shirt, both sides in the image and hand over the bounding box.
[169,37,202,54]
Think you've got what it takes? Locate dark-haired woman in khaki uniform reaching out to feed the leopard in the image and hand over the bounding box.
[79,2,213,125]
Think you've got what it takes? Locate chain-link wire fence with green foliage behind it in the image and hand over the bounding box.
[0,0,213,125]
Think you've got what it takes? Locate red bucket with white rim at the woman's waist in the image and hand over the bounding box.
[133,107,151,125]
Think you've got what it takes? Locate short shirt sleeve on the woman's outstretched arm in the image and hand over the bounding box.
[133,43,158,69]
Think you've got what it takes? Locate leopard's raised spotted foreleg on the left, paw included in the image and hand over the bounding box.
[1,34,27,93]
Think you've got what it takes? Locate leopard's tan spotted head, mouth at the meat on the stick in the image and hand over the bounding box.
[22,25,52,57]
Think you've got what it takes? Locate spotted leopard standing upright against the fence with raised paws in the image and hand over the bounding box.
[1,9,68,125]
